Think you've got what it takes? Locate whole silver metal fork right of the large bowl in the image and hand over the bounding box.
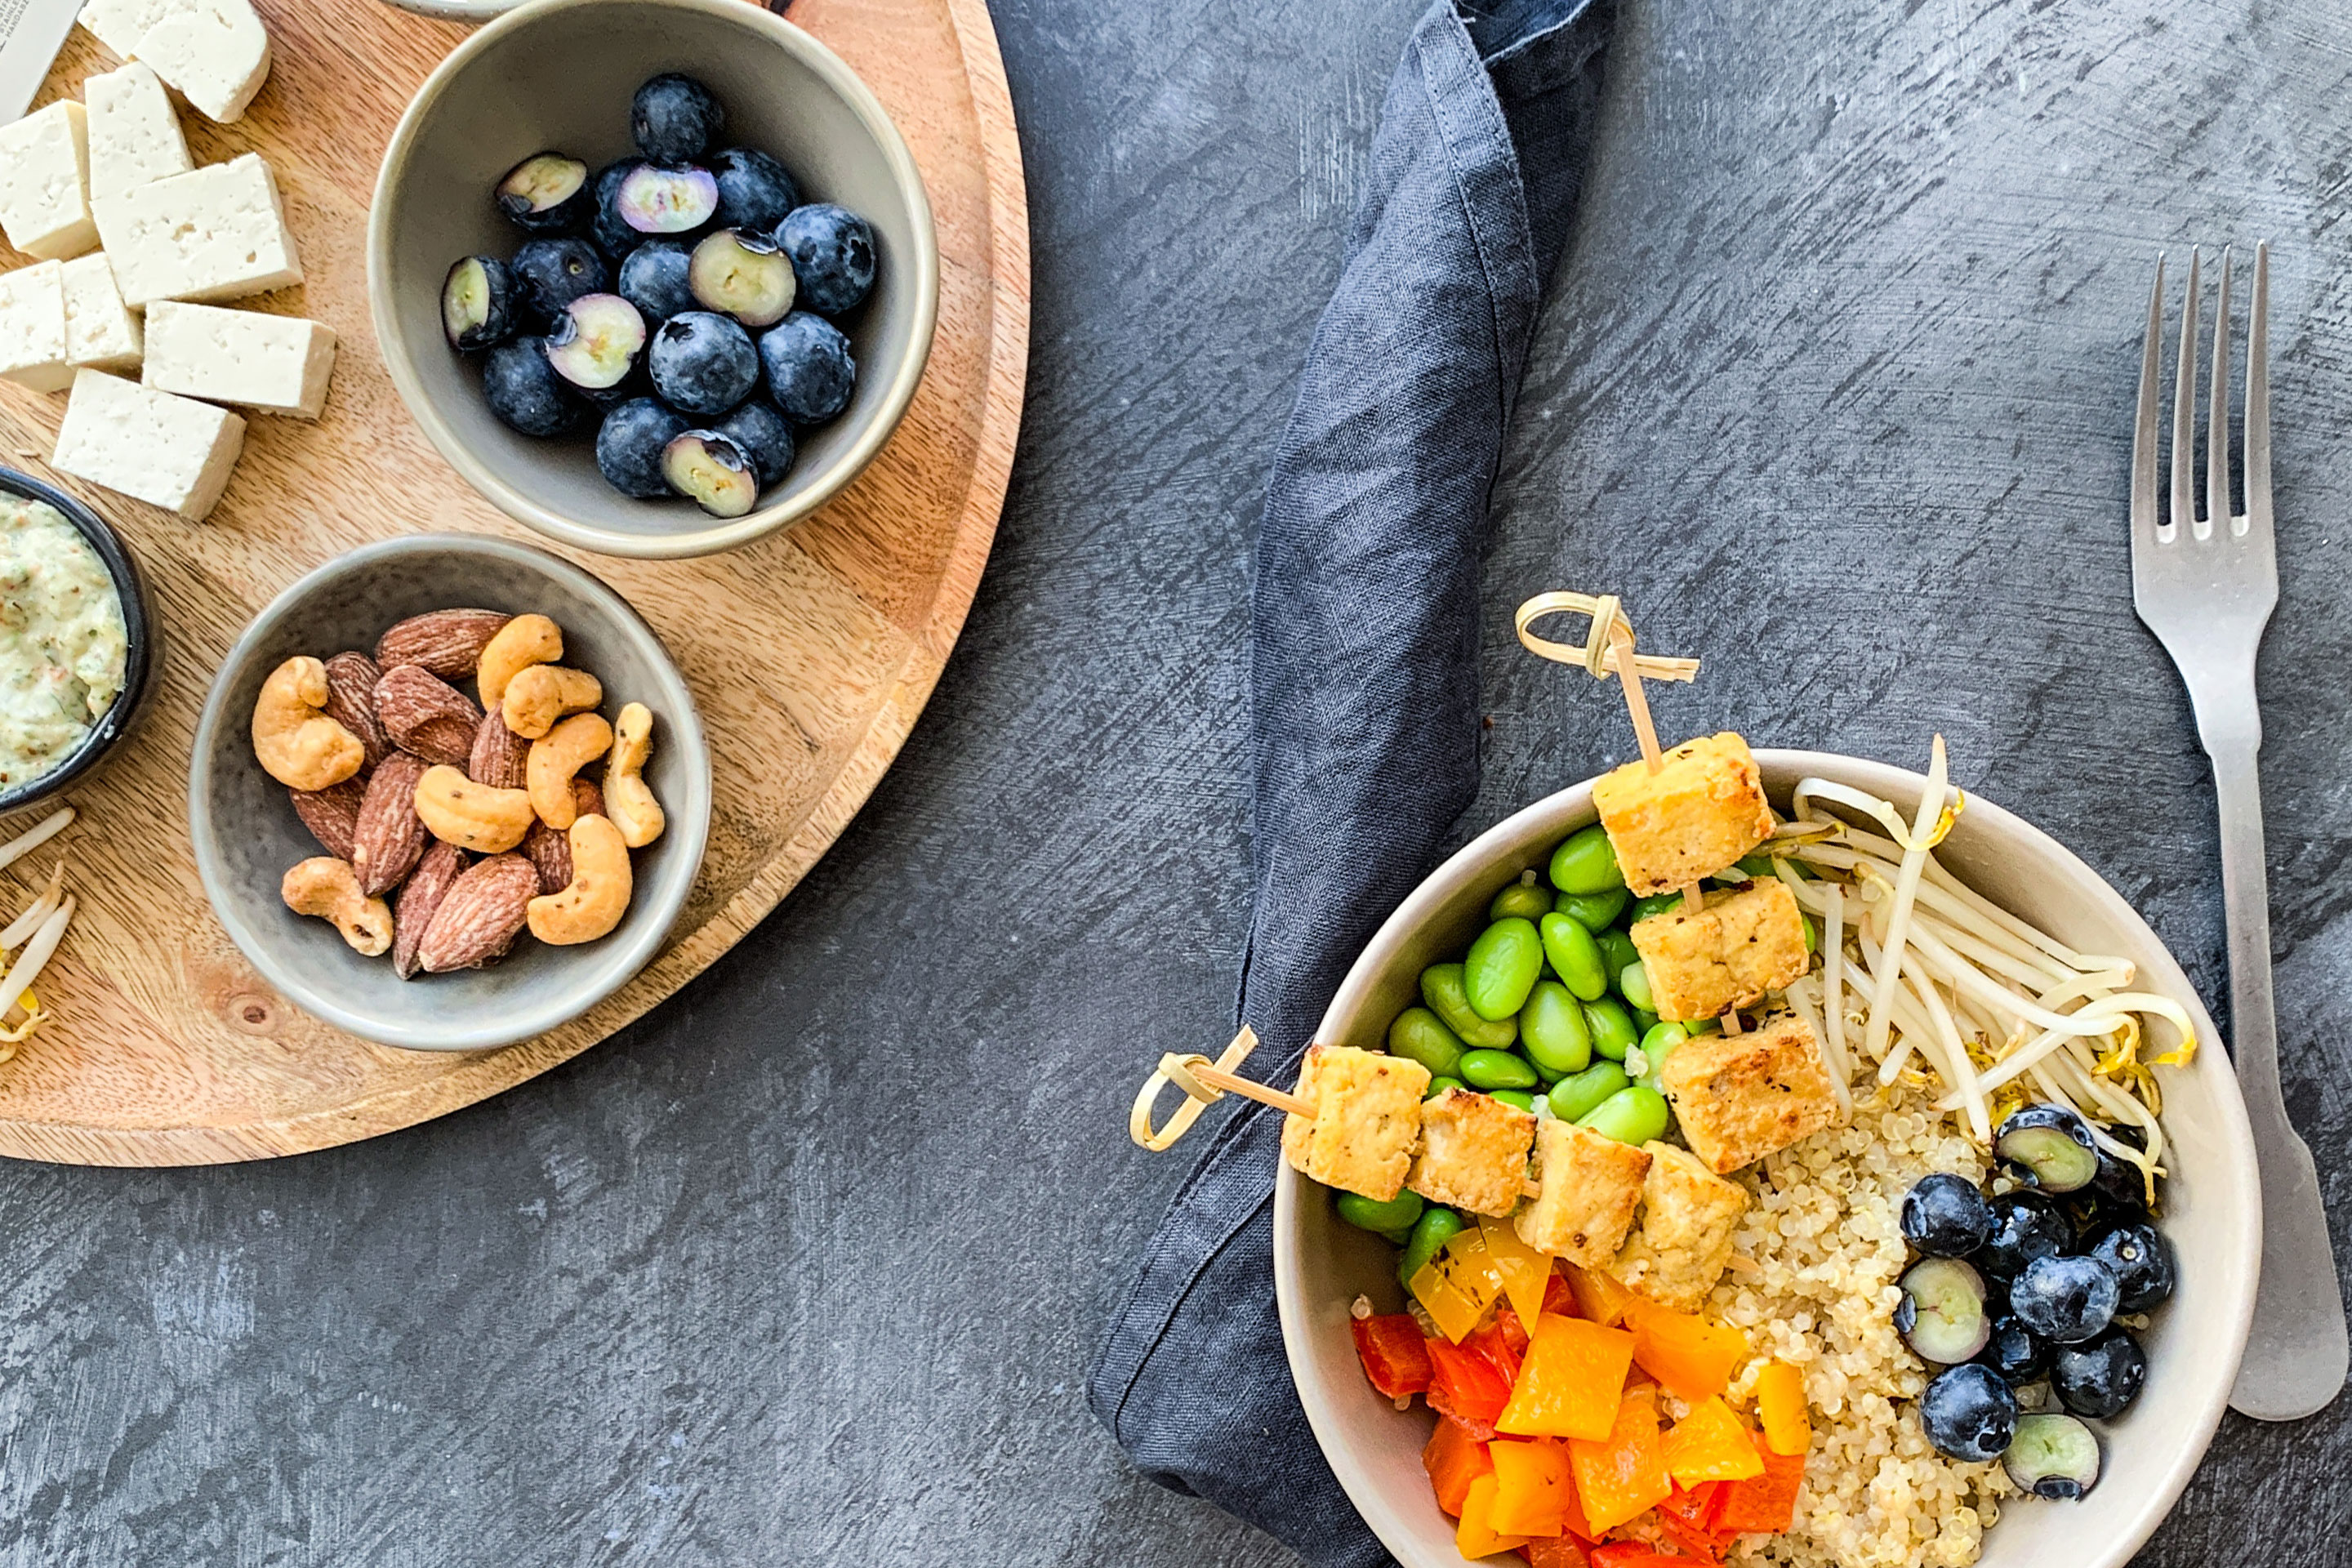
[2131,242,2347,1420]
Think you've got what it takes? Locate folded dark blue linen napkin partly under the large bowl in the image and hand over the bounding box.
[1087,0,1611,1568]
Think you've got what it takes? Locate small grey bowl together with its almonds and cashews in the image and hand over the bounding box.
[188,533,710,1051]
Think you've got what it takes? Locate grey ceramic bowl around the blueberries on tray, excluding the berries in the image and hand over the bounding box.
[367,0,938,557]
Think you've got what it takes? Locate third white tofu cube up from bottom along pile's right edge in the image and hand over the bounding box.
[96,153,301,305]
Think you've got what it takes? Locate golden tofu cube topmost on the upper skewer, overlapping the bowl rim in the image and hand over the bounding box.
[1592,731,1771,898]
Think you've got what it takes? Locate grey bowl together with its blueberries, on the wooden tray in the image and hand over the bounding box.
[367,0,938,557]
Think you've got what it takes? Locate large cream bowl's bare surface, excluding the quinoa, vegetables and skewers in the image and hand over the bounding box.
[1275,750,2263,1568]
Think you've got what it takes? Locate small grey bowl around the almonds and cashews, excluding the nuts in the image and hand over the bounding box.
[188,533,710,1051]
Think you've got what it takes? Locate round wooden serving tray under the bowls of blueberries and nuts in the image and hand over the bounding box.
[0,0,1028,1166]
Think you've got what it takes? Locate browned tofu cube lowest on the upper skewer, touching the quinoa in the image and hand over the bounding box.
[1658,1013,1837,1173]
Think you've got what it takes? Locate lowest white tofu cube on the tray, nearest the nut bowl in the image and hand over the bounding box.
[49,369,245,522]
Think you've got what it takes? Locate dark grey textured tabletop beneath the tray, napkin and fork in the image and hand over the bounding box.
[0,0,2352,1568]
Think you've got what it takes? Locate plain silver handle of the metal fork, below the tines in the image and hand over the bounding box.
[2206,736,2352,1420]
